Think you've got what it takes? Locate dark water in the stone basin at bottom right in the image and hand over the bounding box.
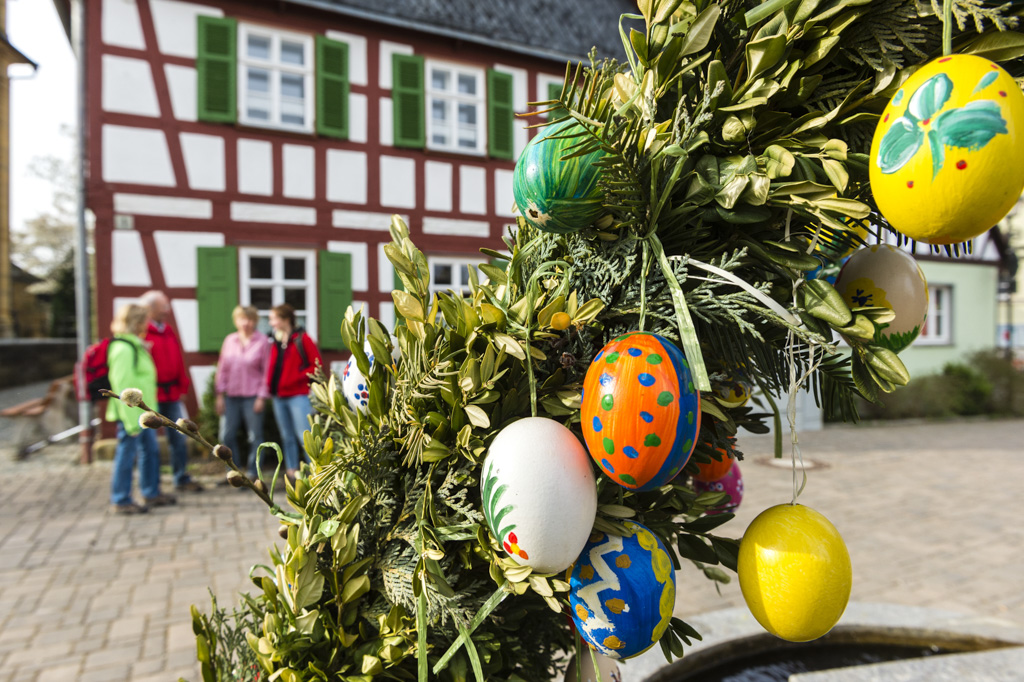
[667,644,948,682]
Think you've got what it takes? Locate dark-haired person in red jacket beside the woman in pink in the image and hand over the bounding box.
[266,303,321,478]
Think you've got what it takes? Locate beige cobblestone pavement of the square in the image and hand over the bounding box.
[0,411,1024,682]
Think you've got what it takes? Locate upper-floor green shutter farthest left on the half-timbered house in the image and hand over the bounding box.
[196,15,238,123]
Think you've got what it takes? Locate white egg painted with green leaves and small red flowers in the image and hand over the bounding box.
[480,417,597,573]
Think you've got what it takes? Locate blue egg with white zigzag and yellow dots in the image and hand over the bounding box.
[569,521,676,658]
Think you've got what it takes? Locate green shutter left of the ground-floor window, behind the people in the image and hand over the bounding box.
[196,247,239,352]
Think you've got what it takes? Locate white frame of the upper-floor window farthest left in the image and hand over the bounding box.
[238,24,315,132]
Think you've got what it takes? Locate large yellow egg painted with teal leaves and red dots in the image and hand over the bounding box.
[869,54,1024,244]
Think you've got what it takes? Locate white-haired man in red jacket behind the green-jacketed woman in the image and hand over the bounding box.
[141,291,203,493]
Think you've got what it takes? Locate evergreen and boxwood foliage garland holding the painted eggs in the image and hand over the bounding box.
[197,0,1019,682]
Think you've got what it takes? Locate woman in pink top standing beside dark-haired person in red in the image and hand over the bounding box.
[215,305,270,477]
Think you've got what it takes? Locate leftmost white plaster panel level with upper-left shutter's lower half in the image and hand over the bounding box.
[102,124,175,187]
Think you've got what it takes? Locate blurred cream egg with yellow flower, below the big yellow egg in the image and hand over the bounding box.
[836,244,928,353]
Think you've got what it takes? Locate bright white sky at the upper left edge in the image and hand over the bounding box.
[7,0,77,236]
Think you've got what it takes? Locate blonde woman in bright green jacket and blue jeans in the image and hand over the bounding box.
[106,304,177,514]
